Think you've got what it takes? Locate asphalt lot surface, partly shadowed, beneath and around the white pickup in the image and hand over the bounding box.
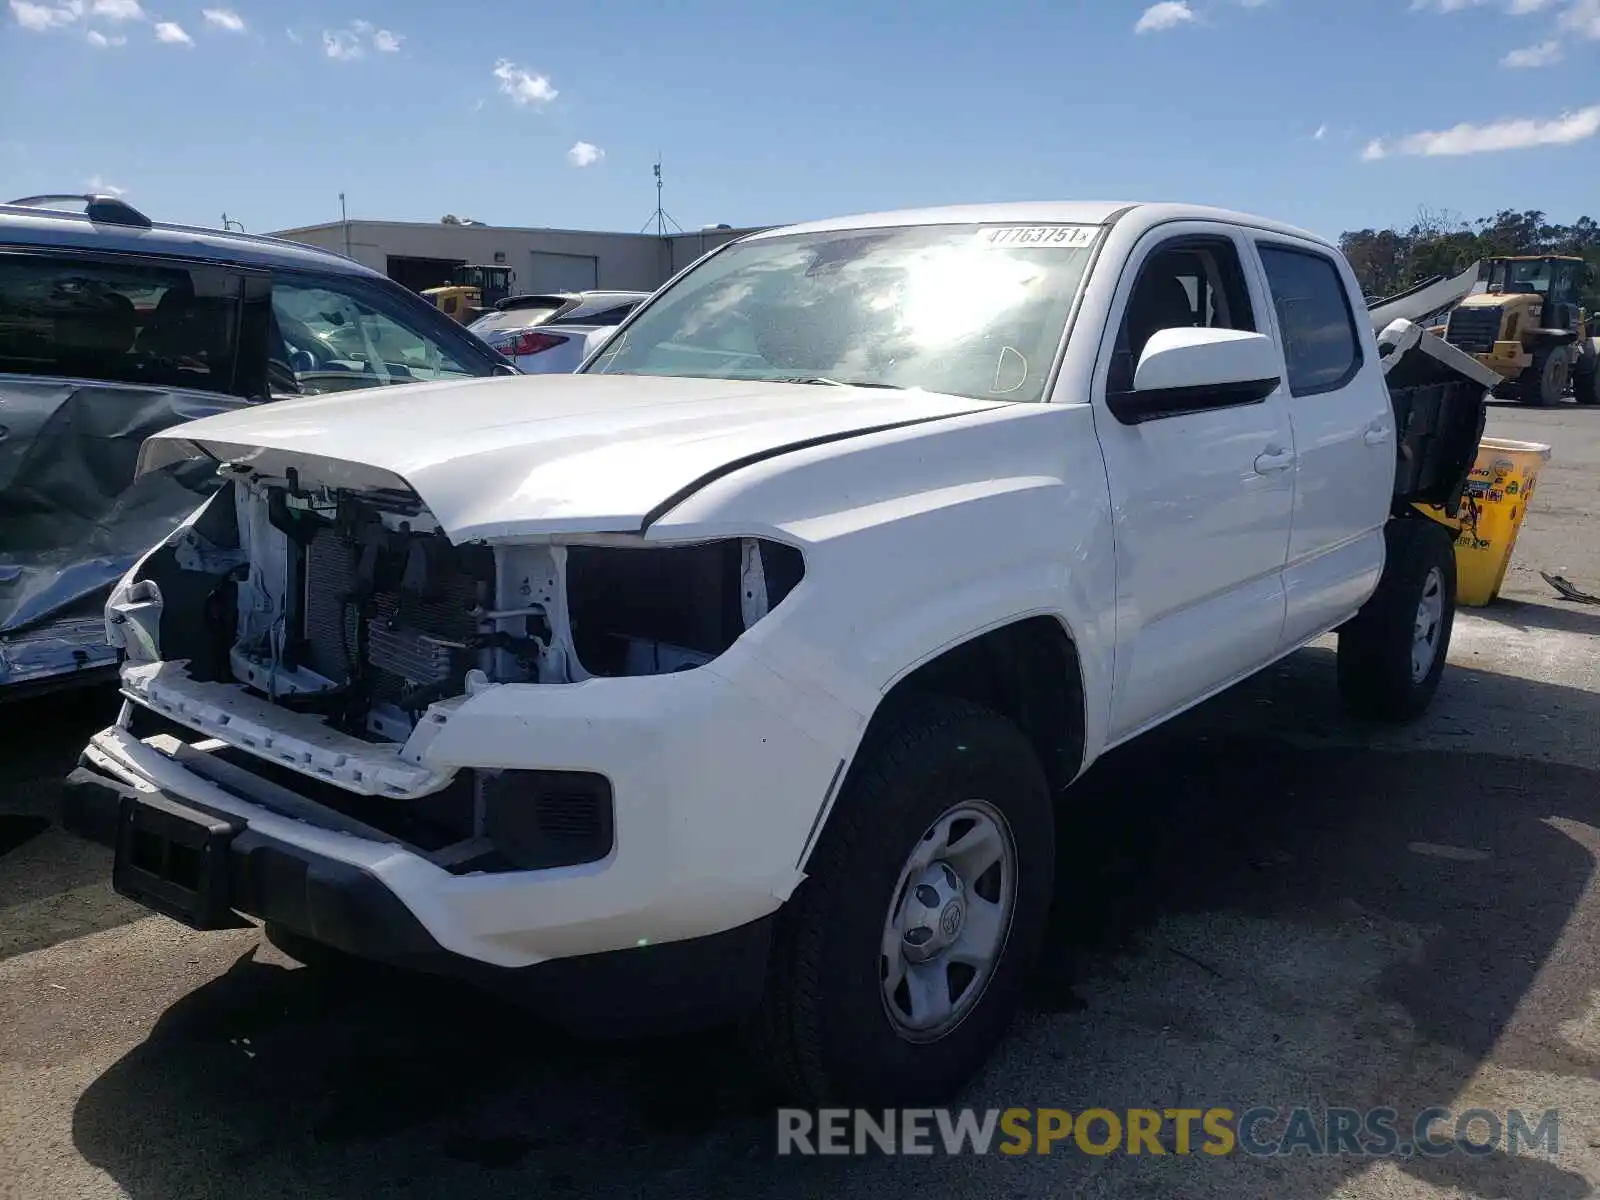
[0,405,1600,1200]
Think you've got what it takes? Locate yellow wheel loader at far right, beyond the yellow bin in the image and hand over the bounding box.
[1445,254,1600,405]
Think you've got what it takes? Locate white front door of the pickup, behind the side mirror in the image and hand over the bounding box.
[1094,222,1294,739]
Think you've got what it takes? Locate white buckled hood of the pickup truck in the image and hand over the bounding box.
[139,374,1006,542]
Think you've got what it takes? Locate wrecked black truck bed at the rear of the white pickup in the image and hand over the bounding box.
[1378,320,1499,515]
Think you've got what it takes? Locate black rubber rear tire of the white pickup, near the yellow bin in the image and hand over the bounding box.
[1339,515,1456,722]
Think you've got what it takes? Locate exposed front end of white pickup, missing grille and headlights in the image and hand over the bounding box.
[91,462,803,874]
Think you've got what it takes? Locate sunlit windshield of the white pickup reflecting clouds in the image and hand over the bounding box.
[589,226,1099,402]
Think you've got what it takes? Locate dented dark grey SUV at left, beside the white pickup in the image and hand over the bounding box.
[0,195,514,699]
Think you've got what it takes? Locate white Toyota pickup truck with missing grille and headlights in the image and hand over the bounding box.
[64,203,1483,1102]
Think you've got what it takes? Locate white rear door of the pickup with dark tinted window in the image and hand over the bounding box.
[1256,238,1395,648]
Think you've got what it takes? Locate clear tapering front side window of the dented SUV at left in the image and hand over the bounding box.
[272,274,488,395]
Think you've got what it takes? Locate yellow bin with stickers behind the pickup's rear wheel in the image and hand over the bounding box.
[1450,437,1550,608]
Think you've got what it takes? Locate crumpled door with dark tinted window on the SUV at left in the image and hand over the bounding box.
[0,246,269,686]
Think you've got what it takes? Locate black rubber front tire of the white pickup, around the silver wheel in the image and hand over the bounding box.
[746,696,1054,1106]
